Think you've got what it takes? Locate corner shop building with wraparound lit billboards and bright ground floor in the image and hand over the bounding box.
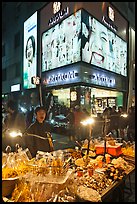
[40,2,128,114]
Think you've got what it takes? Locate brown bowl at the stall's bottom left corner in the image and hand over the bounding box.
[2,177,19,197]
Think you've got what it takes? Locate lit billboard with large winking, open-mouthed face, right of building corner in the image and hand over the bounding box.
[82,12,127,76]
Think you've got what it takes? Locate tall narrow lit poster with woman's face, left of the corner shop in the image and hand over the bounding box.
[23,12,37,89]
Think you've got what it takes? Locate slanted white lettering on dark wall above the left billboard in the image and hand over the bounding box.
[48,7,69,26]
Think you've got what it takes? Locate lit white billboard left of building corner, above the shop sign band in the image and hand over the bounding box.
[42,11,81,72]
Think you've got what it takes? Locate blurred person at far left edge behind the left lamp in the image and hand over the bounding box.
[2,100,26,151]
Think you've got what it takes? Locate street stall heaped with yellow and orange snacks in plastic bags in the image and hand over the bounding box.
[2,135,135,202]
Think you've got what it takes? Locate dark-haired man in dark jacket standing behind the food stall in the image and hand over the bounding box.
[24,106,53,157]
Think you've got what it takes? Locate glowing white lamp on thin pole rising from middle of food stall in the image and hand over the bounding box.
[81,118,94,166]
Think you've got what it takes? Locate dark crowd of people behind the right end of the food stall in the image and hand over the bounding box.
[103,106,135,141]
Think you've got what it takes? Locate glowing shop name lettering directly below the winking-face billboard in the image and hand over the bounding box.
[91,73,116,87]
